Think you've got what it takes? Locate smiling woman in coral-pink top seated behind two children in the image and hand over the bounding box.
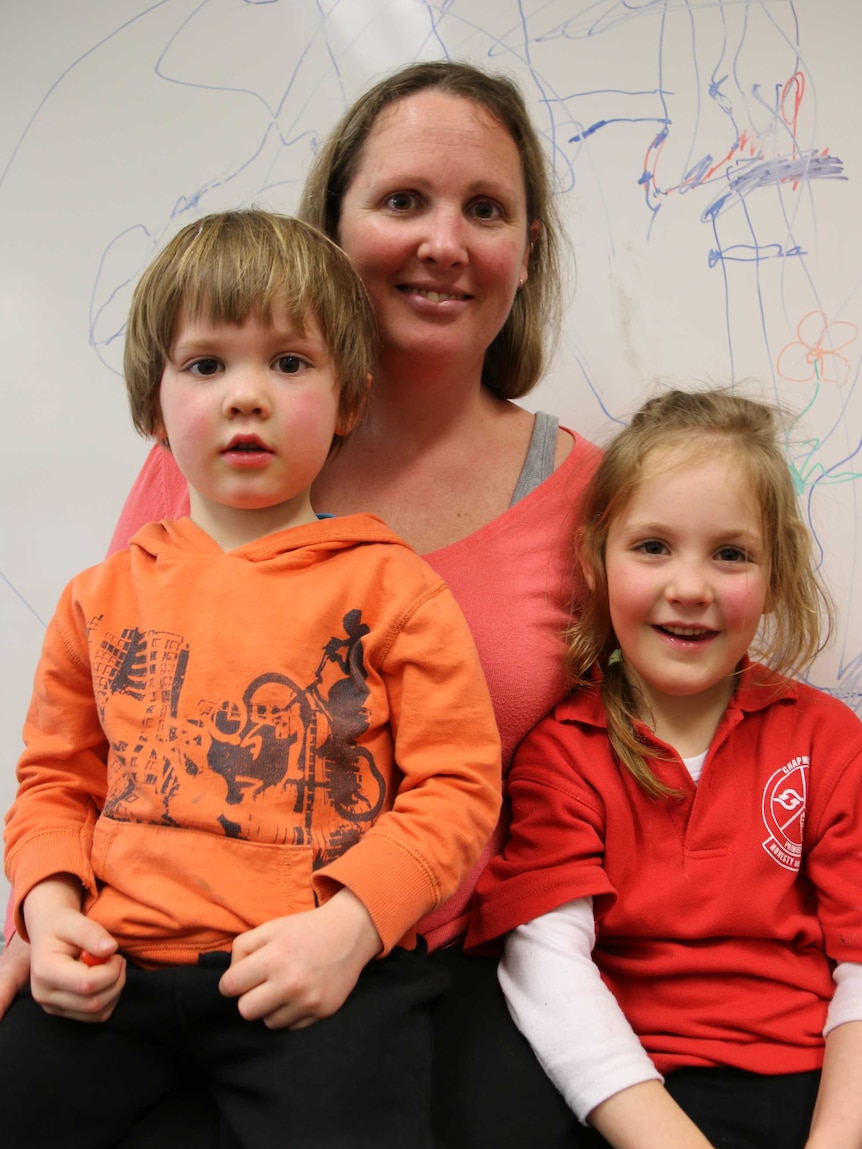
[0,61,598,1149]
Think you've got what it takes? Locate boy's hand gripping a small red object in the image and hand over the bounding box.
[24,874,125,1021]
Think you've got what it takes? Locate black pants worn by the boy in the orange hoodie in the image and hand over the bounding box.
[0,950,446,1149]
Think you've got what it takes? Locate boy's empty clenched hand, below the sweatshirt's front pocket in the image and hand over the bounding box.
[218,889,382,1030]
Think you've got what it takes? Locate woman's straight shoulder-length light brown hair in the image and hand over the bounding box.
[299,60,562,399]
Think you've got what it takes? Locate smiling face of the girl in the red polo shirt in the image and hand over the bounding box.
[605,449,770,717]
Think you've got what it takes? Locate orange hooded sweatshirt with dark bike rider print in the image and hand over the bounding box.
[6,515,500,966]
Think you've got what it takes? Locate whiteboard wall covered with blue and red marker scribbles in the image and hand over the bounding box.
[0,0,862,914]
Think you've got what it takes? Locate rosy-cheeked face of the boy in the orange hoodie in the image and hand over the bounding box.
[156,306,348,549]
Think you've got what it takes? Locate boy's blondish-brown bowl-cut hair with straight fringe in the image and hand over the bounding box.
[124,209,377,437]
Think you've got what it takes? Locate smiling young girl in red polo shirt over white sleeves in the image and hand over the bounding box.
[469,392,862,1149]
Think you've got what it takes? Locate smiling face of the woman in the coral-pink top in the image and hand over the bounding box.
[338,88,531,372]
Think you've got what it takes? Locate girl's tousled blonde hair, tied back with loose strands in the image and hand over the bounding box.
[567,390,833,796]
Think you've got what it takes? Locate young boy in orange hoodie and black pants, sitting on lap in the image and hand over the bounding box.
[0,211,500,1149]
